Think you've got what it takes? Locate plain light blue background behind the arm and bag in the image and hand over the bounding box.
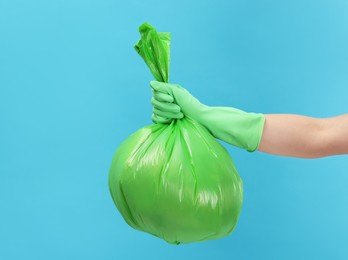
[0,0,348,260]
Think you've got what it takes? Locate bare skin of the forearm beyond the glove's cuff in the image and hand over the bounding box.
[259,114,348,158]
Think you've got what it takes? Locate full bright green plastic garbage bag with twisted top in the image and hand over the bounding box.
[109,23,243,244]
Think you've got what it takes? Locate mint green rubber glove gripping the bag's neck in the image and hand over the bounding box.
[150,81,265,152]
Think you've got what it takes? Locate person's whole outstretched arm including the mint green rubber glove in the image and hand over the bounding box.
[151,81,348,158]
